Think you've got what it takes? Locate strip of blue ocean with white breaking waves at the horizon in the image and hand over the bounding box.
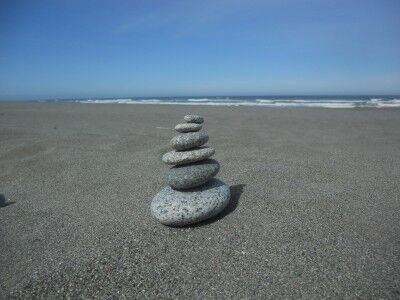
[62,96,400,108]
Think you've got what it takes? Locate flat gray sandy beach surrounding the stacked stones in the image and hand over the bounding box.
[0,103,400,299]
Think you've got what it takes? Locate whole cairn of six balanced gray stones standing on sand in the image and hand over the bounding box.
[151,115,230,226]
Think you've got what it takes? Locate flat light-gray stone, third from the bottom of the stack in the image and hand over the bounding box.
[162,147,215,165]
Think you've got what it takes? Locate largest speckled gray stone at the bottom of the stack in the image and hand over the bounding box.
[151,178,230,226]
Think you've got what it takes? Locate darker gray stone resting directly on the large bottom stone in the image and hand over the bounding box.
[165,159,219,189]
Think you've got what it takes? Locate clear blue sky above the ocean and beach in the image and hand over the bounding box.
[0,0,400,100]
